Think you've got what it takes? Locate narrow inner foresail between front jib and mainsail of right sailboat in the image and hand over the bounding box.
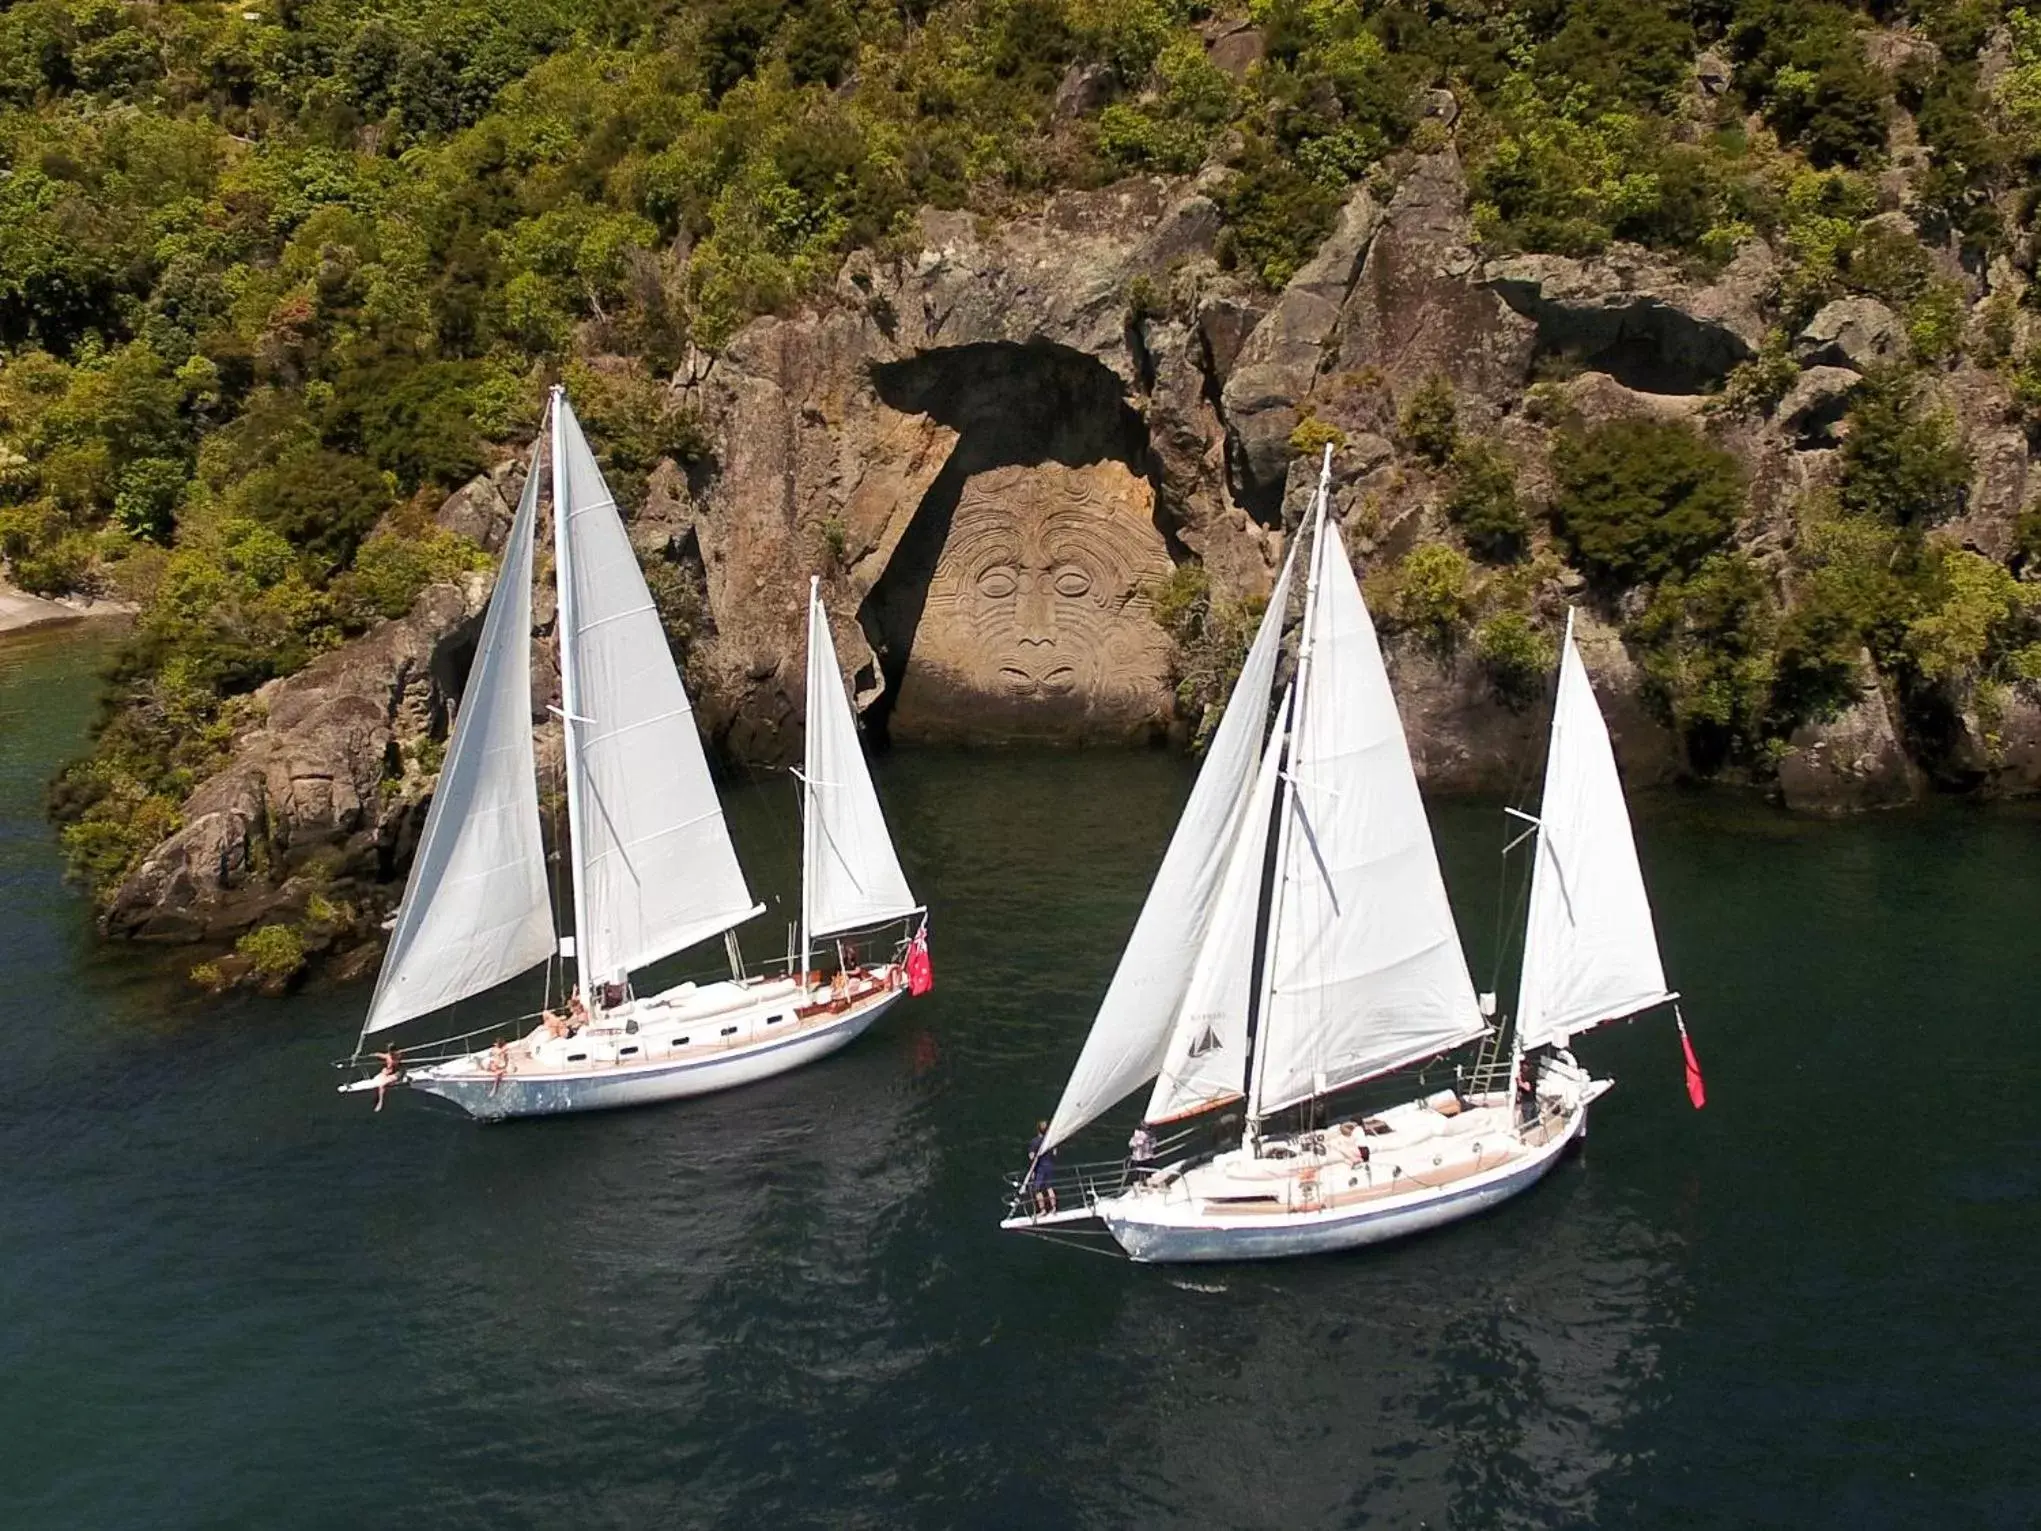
[1143,696,1290,1123]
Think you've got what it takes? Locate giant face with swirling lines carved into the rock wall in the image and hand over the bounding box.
[892,461,1172,739]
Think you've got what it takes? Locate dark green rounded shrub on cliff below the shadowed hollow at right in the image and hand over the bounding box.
[1551,421,1743,588]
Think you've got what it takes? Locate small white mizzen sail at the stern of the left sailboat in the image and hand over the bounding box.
[802,580,920,935]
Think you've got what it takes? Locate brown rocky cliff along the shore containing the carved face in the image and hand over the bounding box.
[106,113,2041,963]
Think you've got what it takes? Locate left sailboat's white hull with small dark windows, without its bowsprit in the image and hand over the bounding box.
[404,982,906,1121]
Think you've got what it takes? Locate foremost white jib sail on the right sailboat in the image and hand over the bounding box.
[1047,538,1296,1147]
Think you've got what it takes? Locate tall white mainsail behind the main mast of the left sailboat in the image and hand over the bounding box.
[553,394,761,984]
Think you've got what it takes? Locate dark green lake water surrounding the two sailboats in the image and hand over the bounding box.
[0,635,2041,1531]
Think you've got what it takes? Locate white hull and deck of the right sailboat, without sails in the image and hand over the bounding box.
[1096,1080,1608,1264]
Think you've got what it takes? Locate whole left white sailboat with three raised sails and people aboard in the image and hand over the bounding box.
[341,388,929,1121]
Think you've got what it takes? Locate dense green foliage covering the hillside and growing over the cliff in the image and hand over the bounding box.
[0,0,2041,888]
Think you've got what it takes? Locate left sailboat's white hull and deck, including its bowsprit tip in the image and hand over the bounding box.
[357,966,906,1121]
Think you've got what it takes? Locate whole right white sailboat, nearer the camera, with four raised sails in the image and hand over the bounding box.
[1002,451,1676,1262]
